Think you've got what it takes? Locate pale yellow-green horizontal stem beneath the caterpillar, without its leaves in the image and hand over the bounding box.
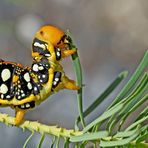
[0,113,82,138]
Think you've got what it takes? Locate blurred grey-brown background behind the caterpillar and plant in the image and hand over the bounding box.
[0,0,148,148]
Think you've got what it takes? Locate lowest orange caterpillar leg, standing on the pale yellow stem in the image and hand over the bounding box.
[14,109,26,126]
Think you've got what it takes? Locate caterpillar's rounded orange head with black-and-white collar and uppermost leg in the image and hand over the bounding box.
[32,25,76,61]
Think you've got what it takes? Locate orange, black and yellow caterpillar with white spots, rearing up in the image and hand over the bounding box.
[0,25,79,126]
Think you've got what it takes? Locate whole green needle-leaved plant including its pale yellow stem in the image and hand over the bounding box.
[0,33,148,148]
